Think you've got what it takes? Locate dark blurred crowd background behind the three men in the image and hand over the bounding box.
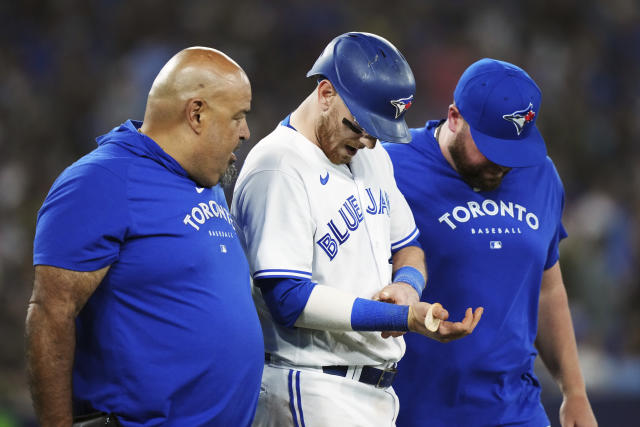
[0,0,640,427]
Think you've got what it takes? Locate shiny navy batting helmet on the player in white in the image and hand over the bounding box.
[307,32,416,142]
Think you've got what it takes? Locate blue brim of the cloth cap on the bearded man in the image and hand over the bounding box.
[469,126,547,168]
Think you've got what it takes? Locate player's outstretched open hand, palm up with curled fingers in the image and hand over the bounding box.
[408,302,484,342]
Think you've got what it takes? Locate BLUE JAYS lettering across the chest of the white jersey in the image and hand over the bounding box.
[316,187,391,260]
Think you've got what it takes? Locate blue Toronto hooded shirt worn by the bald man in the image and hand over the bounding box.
[34,121,264,426]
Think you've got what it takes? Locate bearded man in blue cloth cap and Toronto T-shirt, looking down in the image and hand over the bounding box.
[384,59,596,427]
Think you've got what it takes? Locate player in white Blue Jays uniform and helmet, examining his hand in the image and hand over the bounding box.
[232,33,482,427]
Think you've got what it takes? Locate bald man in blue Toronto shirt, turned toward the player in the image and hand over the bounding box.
[27,47,264,426]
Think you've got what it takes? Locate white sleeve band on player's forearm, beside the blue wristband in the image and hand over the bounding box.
[295,285,356,331]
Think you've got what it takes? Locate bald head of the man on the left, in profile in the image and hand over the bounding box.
[140,47,251,187]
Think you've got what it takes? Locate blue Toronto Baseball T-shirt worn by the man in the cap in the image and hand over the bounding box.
[384,121,566,427]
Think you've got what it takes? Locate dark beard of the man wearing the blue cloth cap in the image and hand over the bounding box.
[449,133,508,191]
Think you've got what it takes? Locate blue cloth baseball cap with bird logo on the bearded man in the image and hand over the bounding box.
[453,58,547,167]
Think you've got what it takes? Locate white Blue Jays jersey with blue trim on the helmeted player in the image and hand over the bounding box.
[232,124,418,366]
